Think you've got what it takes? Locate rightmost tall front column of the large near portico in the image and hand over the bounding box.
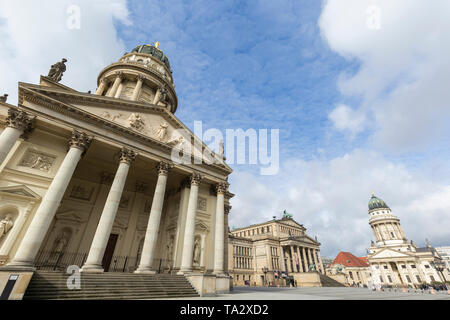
[214,182,228,274]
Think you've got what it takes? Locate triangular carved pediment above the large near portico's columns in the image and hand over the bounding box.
[19,83,232,172]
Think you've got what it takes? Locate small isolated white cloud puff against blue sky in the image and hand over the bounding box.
[328,104,366,136]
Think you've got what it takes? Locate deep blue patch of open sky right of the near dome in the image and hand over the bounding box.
[118,1,366,159]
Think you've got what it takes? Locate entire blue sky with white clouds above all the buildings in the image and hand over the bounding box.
[0,0,450,258]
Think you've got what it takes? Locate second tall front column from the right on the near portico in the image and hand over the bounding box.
[178,173,202,274]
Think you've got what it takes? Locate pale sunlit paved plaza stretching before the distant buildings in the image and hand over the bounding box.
[162,287,450,300]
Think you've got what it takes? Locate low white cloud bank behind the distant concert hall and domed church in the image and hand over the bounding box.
[230,150,450,257]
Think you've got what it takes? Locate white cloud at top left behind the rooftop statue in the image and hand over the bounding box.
[0,0,130,104]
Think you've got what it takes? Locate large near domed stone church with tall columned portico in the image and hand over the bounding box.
[0,43,233,298]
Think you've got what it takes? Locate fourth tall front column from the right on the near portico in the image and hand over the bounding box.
[80,148,136,272]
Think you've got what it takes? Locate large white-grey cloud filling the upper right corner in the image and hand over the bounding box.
[319,0,450,151]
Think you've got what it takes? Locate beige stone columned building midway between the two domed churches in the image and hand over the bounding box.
[228,216,324,286]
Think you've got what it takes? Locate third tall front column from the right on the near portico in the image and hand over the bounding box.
[135,162,172,273]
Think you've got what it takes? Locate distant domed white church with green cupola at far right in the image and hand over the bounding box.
[367,195,445,287]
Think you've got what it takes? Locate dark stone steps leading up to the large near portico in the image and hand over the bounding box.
[23,271,199,300]
